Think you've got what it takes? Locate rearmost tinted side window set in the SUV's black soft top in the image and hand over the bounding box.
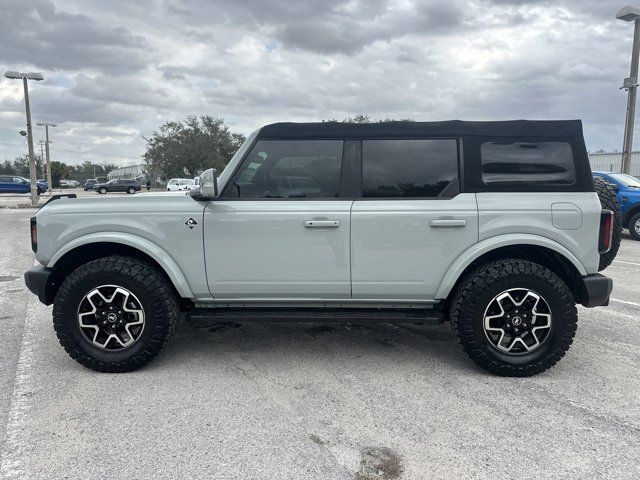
[480,141,576,185]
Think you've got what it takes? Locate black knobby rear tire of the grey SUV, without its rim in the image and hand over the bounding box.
[449,259,578,377]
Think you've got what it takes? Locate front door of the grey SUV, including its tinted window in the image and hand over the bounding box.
[204,140,353,301]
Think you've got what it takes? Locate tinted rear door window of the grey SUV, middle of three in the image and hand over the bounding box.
[362,139,458,198]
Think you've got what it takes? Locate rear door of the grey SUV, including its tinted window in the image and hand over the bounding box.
[351,138,478,300]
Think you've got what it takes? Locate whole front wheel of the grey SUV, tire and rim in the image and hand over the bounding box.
[53,256,179,372]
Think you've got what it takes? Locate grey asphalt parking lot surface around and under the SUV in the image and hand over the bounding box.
[0,201,640,480]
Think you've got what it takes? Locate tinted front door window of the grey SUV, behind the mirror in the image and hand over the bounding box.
[223,140,343,198]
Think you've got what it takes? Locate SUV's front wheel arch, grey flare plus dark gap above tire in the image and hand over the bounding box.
[46,233,193,300]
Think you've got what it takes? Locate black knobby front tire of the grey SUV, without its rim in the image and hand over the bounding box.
[53,256,179,372]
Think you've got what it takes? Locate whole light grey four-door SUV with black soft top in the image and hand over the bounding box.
[25,121,613,377]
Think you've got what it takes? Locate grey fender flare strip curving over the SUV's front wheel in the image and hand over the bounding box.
[47,232,194,298]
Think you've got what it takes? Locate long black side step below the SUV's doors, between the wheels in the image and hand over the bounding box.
[186,308,445,326]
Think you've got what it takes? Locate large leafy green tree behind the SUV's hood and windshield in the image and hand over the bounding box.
[143,115,244,179]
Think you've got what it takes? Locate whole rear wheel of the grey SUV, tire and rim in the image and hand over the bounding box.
[449,259,578,377]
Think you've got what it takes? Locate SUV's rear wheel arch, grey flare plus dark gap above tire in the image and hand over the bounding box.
[435,235,587,303]
